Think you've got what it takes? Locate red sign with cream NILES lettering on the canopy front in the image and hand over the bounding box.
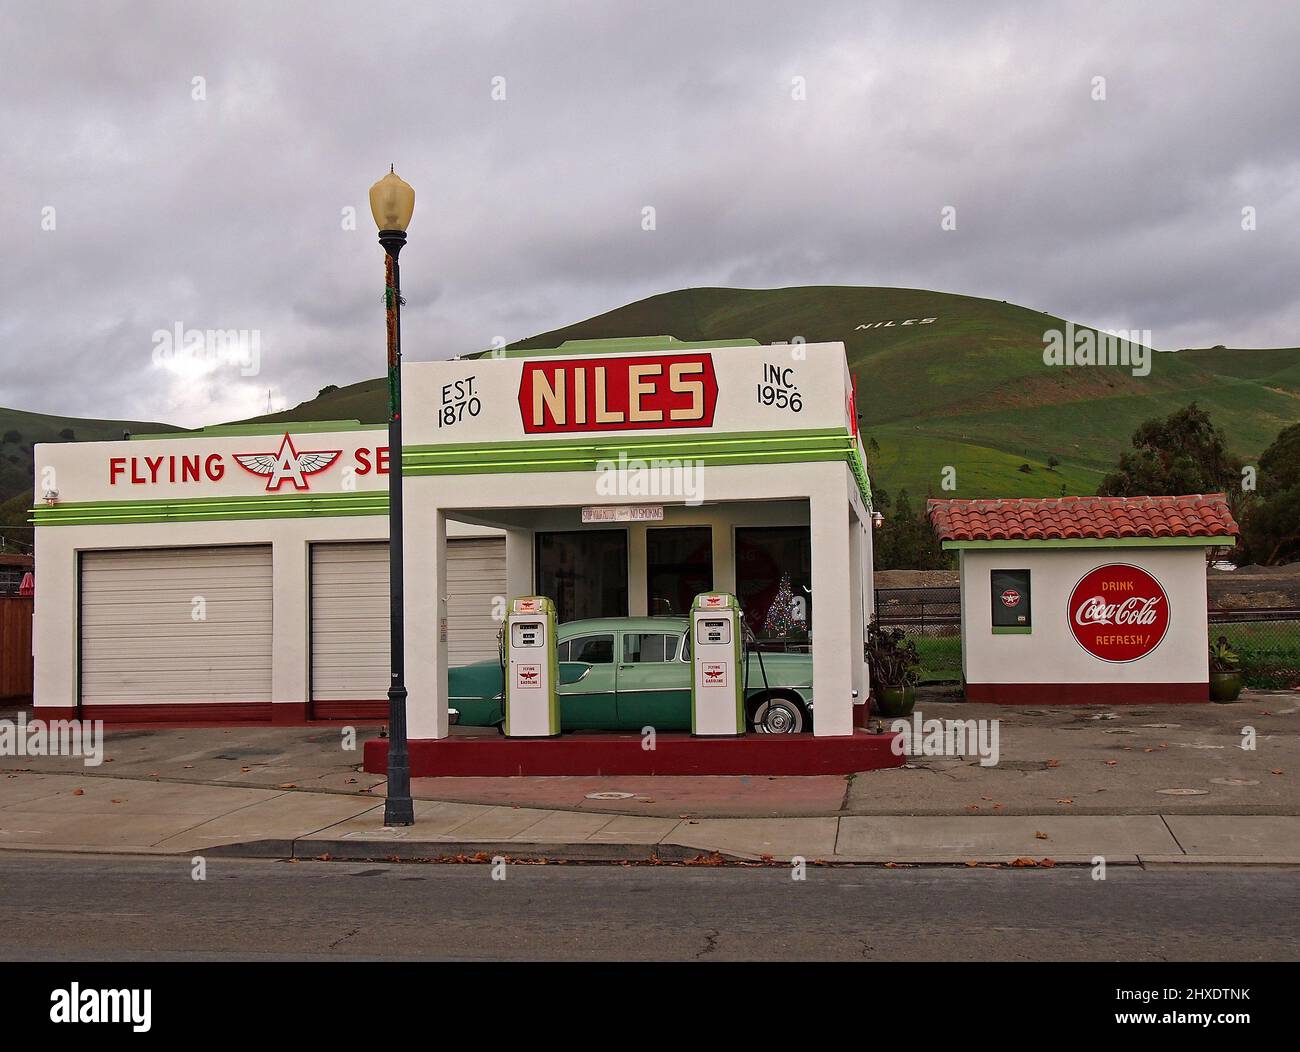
[519,354,718,434]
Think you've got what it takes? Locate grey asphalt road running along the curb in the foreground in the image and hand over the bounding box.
[0,853,1300,961]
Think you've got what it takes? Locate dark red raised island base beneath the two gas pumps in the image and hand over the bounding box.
[363,731,906,778]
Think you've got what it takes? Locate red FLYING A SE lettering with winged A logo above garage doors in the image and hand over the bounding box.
[108,433,389,493]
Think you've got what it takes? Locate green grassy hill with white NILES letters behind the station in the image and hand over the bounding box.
[0,286,1300,533]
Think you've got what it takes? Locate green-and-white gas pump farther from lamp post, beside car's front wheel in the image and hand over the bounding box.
[690,592,745,737]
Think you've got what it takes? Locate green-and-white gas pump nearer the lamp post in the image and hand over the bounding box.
[503,596,560,737]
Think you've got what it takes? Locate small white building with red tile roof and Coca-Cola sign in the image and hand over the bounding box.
[927,493,1239,705]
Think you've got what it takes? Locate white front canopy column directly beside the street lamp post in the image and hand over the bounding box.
[403,499,449,741]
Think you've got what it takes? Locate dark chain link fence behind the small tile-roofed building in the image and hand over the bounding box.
[876,588,1300,690]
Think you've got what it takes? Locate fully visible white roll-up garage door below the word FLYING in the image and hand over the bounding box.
[81,545,272,705]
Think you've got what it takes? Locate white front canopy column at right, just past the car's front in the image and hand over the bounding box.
[807,463,862,737]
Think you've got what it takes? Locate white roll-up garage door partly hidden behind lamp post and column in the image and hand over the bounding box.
[312,537,506,701]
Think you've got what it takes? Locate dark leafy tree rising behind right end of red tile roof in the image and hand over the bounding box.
[1097,402,1242,506]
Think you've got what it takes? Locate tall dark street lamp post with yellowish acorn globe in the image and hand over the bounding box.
[371,166,415,826]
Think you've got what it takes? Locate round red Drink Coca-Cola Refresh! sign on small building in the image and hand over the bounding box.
[1070,563,1169,662]
